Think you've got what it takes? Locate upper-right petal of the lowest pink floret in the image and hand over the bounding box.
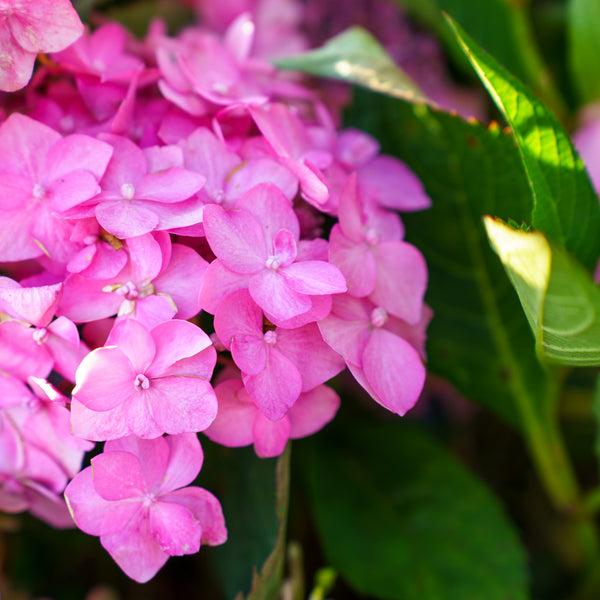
[156,432,204,494]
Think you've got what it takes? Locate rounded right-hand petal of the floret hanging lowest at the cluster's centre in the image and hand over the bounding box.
[287,385,340,439]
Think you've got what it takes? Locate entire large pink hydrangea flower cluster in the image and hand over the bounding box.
[0,0,431,582]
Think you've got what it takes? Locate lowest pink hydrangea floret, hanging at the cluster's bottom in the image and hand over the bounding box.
[65,433,227,583]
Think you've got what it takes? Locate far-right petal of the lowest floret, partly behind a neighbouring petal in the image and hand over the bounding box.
[162,486,227,546]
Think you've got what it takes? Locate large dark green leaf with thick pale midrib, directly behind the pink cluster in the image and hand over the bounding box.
[347,90,575,507]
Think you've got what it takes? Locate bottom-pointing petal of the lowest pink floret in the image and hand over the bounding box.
[100,515,169,583]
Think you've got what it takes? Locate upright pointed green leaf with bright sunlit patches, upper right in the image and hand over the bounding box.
[448,14,600,270]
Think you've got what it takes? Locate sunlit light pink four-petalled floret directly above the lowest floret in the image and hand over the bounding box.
[71,319,217,441]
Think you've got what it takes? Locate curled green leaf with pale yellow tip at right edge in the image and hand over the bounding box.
[485,218,600,366]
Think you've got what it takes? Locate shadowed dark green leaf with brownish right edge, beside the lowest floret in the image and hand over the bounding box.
[201,440,290,600]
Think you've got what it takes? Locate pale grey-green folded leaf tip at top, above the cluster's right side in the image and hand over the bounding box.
[274,27,425,100]
